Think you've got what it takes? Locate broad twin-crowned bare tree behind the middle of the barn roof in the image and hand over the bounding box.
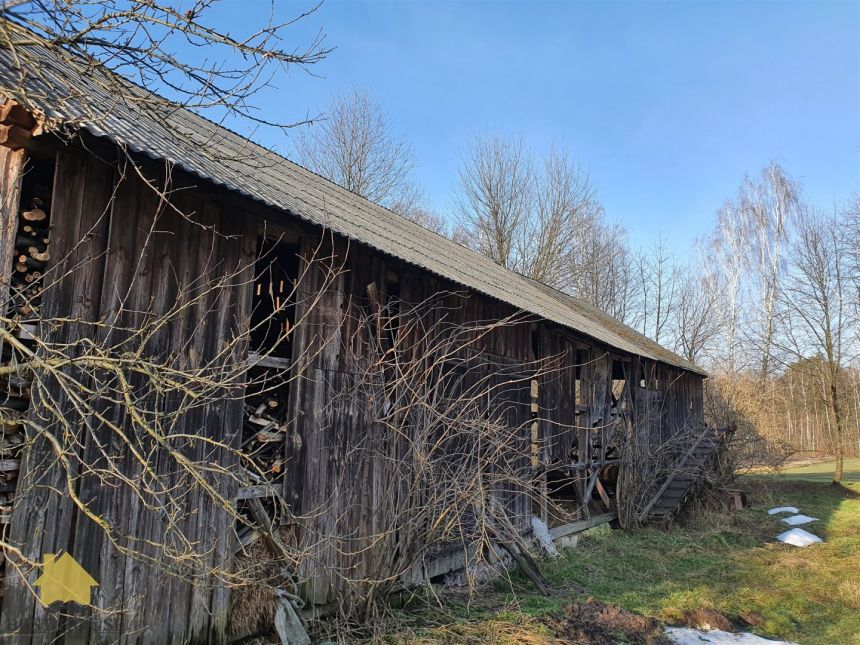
[456,134,616,302]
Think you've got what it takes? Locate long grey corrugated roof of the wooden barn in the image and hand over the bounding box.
[0,36,704,374]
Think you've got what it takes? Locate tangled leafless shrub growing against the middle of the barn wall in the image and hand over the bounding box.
[302,292,572,622]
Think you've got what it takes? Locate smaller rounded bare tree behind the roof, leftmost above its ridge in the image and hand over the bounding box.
[296,90,428,219]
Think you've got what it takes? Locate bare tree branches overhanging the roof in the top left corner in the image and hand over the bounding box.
[0,0,330,128]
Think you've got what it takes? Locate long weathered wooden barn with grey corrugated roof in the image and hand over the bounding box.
[0,37,706,643]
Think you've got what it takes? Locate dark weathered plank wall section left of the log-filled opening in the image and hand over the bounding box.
[0,150,256,643]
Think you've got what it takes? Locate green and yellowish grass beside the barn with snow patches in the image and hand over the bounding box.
[386,476,860,645]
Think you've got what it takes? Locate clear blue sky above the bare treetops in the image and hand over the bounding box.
[215,0,860,251]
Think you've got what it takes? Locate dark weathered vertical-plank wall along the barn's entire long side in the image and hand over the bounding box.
[0,138,702,643]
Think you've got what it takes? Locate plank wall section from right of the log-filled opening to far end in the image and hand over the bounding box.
[284,236,701,603]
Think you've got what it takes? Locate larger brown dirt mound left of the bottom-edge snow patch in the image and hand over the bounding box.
[548,600,671,645]
